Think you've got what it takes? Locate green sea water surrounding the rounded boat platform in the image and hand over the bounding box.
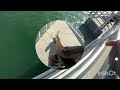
[0,11,87,78]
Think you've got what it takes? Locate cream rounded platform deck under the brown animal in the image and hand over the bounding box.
[35,20,81,66]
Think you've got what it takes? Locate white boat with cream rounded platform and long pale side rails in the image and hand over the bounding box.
[33,11,120,79]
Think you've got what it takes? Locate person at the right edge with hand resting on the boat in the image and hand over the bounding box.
[106,40,120,77]
